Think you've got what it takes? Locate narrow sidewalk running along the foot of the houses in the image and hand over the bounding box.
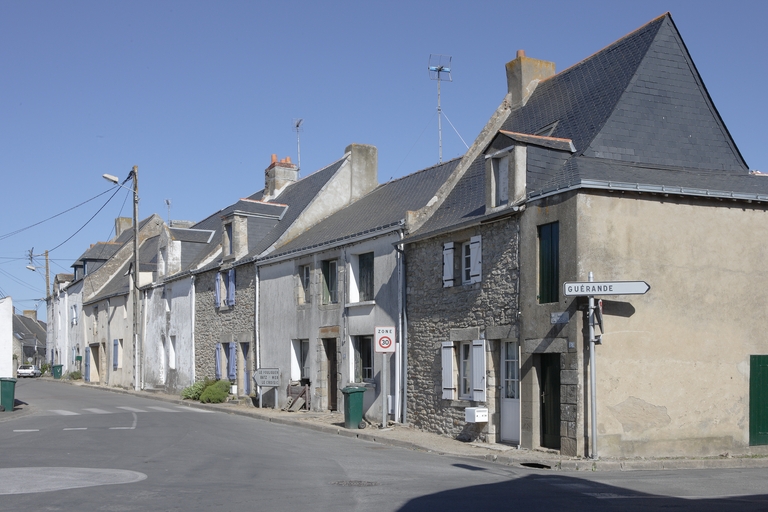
[18,377,768,471]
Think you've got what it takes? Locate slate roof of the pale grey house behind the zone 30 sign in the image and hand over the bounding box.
[259,159,460,261]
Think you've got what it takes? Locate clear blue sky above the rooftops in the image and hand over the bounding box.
[0,0,768,318]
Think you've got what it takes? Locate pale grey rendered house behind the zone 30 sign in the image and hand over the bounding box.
[257,161,457,423]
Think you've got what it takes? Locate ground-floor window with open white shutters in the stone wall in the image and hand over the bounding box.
[441,340,486,402]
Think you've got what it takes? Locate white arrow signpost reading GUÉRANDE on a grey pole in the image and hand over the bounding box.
[563,272,651,459]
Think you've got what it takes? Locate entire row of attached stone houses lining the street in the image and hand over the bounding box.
[49,14,768,456]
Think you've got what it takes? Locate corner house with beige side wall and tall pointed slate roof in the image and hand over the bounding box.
[405,14,768,456]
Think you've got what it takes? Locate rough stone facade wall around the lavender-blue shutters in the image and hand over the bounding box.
[195,264,256,384]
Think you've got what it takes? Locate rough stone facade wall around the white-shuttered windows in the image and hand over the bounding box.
[406,217,519,442]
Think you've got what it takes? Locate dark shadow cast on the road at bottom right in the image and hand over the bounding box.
[399,474,768,512]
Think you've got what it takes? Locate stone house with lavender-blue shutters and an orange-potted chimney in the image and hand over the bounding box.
[191,144,377,395]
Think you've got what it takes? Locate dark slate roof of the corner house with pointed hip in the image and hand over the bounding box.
[410,13,768,239]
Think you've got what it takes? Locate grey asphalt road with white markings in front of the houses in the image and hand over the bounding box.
[0,379,768,512]
